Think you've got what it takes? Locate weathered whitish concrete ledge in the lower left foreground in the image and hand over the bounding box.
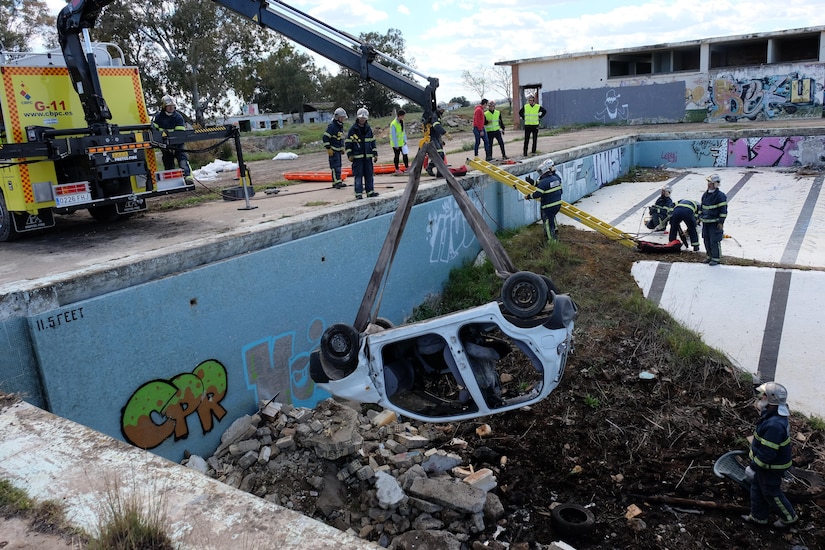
[0,402,379,550]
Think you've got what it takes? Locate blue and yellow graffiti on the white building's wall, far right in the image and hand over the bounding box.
[708,72,822,122]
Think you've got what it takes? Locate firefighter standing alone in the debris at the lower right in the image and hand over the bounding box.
[742,382,799,529]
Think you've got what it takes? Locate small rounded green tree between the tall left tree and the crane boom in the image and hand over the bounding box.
[253,40,321,113]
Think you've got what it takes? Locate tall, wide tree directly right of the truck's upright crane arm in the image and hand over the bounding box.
[93,0,277,125]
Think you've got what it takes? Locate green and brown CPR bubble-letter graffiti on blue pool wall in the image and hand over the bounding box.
[121,359,227,449]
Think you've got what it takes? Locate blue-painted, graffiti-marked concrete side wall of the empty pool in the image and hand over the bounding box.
[0,132,825,461]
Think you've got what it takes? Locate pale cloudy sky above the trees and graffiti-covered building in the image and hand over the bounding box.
[48,0,825,108]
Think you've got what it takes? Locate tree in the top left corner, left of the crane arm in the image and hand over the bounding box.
[0,0,57,51]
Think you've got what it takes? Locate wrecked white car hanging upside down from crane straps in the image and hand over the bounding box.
[310,271,577,422]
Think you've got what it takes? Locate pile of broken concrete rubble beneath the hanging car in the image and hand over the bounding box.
[183,399,520,550]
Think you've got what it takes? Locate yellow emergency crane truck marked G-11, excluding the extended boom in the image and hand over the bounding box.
[0,0,246,242]
